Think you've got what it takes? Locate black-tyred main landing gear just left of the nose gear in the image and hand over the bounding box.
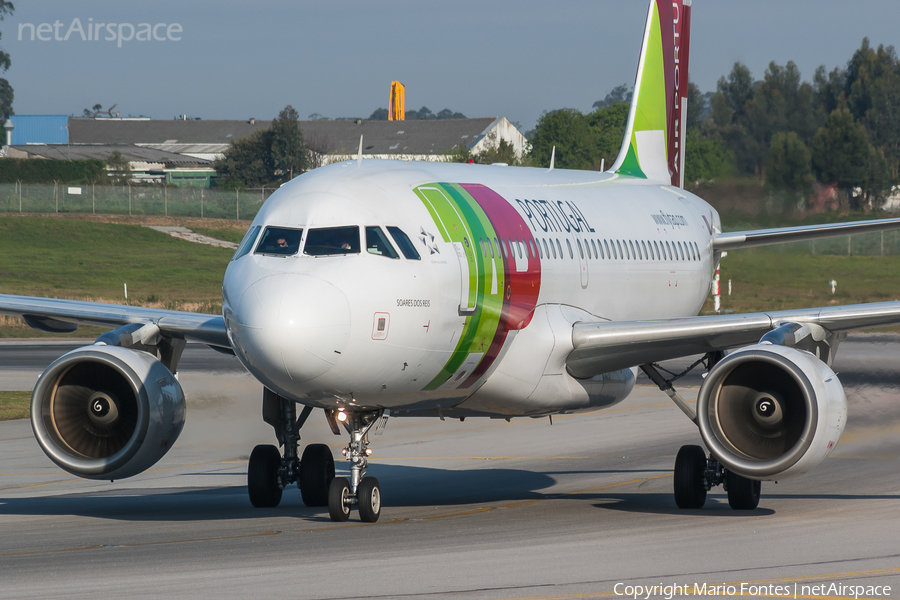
[247,389,334,508]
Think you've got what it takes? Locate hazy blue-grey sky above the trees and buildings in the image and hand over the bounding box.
[0,0,900,132]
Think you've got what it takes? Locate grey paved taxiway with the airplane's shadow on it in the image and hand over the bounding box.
[0,335,900,599]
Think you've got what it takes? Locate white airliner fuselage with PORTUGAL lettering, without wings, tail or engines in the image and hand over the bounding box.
[223,160,720,417]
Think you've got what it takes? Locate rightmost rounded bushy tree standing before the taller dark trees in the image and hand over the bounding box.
[812,108,869,192]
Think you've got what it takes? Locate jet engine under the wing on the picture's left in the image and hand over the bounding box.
[31,345,185,480]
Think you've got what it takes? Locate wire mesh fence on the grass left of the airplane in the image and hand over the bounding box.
[0,183,278,220]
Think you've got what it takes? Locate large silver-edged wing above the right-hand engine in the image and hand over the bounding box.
[566,302,900,378]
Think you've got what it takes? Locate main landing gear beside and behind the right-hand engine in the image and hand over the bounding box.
[641,352,762,510]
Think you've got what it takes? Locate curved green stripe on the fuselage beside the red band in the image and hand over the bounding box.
[414,183,506,390]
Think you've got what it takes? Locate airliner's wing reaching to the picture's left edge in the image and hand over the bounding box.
[0,294,231,350]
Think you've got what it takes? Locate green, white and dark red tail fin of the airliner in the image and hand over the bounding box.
[609,0,692,187]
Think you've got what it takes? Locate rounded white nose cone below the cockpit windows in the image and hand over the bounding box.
[234,274,350,388]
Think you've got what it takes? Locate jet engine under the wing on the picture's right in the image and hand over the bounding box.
[697,344,847,480]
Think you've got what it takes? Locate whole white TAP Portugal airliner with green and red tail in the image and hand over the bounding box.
[0,0,900,522]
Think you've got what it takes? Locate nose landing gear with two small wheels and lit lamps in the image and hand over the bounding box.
[326,410,390,523]
